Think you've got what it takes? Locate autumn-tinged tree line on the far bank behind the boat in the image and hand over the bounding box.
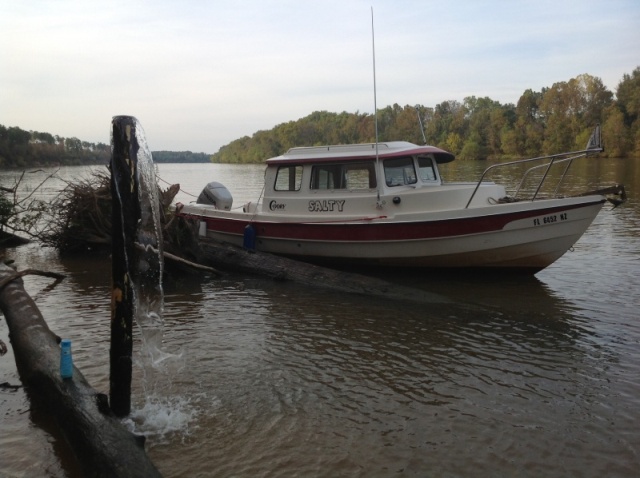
[211,67,640,163]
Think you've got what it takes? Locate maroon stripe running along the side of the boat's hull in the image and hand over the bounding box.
[186,201,601,242]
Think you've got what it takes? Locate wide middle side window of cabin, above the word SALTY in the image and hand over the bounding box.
[311,162,376,190]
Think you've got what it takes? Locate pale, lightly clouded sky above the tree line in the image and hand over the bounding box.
[0,0,640,153]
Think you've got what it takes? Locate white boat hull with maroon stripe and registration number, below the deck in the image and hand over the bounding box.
[181,196,604,272]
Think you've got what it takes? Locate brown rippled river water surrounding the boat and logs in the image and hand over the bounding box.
[0,159,640,477]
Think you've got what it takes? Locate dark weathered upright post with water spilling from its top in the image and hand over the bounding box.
[109,116,140,417]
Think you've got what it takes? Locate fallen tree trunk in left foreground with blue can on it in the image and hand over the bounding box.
[0,264,161,477]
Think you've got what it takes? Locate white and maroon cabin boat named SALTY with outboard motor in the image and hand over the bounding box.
[177,131,624,273]
